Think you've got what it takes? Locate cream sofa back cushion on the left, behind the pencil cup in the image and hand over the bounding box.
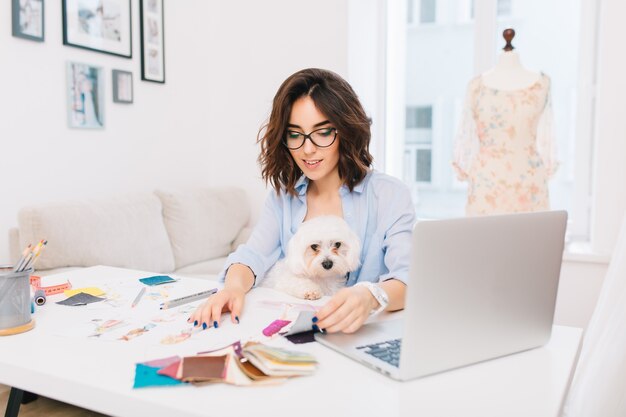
[18,193,174,272]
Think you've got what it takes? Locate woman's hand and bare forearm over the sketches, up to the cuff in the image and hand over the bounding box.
[187,264,254,329]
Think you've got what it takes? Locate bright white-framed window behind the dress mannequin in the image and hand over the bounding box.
[384,0,595,234]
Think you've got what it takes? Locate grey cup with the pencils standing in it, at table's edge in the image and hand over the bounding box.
[0,240,48,336]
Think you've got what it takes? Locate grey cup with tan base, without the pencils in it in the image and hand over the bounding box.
[0,267,34,336]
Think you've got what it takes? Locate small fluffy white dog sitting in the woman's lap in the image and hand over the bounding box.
[261,216,361,300]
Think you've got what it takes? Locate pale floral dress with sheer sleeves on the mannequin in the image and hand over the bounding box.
[452,74,558,215]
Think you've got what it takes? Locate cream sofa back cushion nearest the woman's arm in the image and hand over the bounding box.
[155,187,250,269]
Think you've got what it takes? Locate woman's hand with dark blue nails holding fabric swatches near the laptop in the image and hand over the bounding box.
[313,285,378,333]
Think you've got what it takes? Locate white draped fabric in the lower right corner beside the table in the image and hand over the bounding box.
[563,216,626,417]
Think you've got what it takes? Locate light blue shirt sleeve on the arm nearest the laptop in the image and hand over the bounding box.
[379,181,415,284]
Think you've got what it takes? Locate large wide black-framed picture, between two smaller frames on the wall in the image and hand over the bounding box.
[63,0,132,58]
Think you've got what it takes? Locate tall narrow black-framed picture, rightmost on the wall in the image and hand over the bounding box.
[139,0,165,83]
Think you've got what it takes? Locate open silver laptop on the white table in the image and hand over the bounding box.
[315,211,567,380]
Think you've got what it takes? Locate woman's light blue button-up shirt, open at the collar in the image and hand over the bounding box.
[220,171,415,286]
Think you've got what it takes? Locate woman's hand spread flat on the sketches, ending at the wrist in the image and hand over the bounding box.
[187,288,246,329]
